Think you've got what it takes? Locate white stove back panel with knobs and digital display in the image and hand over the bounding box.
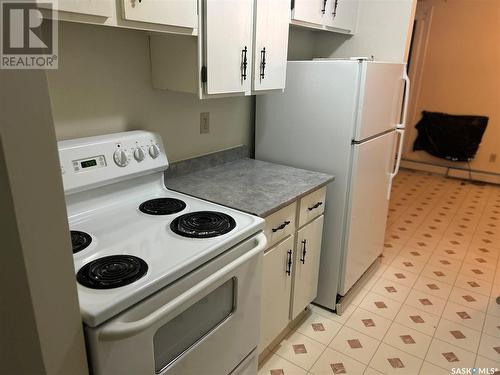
[58,131,168,194]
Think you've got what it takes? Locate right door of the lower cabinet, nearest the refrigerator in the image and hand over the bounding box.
[291,215,323,319]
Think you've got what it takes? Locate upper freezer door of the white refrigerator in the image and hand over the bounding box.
[354,62,404,141]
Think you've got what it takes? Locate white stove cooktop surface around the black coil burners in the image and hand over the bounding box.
[69,184,264,326]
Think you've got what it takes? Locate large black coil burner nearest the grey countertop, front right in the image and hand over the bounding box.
[170,211,236,238]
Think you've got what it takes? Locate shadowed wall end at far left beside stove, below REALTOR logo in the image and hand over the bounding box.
[0,70,88,375]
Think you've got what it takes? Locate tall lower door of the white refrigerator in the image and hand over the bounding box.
[339,131,396,296]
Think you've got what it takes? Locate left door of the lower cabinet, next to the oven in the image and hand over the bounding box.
[259,236,294,353]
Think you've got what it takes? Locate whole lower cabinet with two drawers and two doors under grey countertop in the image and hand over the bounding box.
[258,187,326,354]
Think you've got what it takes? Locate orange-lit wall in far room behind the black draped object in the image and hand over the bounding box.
[404,0,500,173]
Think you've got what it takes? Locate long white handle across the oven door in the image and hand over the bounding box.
[99,233,267,341]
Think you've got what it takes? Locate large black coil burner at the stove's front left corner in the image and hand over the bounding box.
[76,255,148,289]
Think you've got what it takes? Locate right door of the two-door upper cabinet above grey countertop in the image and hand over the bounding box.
[253,0,290,91]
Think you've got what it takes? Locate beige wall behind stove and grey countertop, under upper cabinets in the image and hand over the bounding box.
[48,22,254,161]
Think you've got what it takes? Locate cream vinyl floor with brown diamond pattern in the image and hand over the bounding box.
[259,170,500,375]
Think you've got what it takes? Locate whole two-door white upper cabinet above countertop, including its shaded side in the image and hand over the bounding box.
[150,0,290,99]
